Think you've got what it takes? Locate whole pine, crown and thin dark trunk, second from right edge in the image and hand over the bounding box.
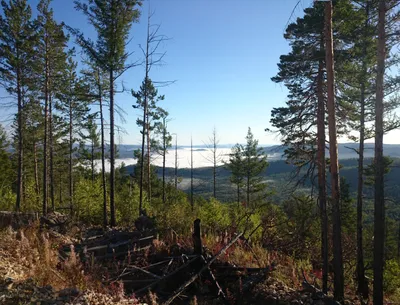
[338,0,399,299]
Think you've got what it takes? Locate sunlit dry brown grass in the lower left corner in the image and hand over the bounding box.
[0,224,151,305]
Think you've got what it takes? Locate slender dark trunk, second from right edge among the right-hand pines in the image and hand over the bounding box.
[357,2,369,299]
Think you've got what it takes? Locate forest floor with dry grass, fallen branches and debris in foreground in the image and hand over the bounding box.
[0,214,359,305]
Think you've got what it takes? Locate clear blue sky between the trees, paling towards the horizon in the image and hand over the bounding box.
[2,0,400,145]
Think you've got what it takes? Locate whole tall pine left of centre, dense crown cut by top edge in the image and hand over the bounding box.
[69,0,141,226]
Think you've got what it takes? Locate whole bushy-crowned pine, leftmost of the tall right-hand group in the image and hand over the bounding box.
[271,1,358,292]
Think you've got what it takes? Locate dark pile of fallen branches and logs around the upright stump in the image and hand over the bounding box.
[60,219,272,305]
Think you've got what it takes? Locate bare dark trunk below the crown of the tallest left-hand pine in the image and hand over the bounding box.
[109,69,116,227]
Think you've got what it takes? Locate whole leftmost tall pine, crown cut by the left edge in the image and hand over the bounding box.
[0,0,35,211]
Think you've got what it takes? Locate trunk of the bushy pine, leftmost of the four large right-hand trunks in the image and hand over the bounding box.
[317,55,328,294]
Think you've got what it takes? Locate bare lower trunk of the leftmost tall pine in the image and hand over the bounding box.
[15,67,24,212]
